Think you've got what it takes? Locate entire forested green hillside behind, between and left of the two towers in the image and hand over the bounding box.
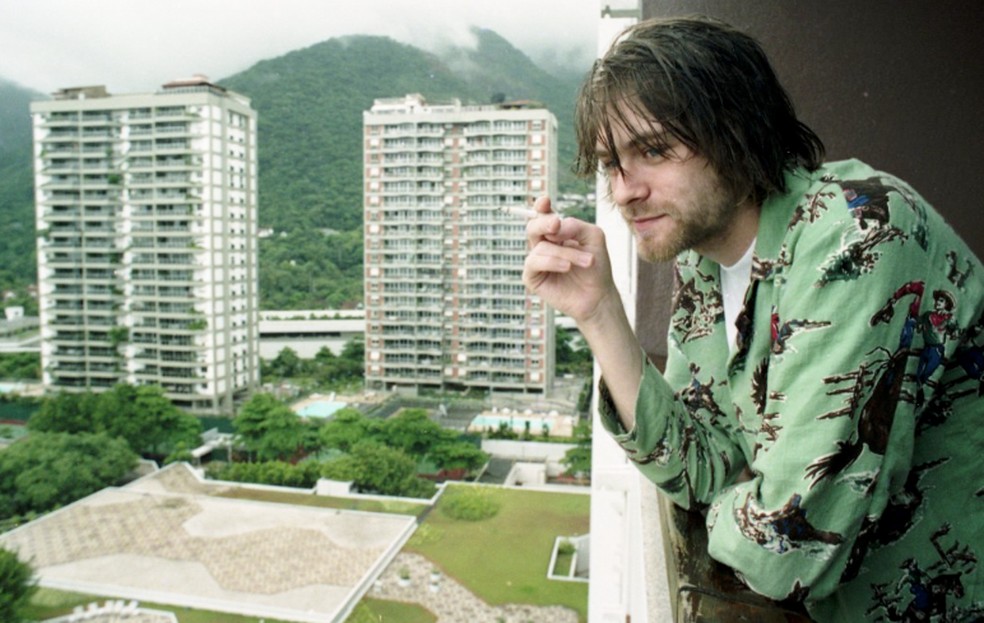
[0,30,587,309]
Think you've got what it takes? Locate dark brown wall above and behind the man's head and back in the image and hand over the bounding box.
[642,0,984,258]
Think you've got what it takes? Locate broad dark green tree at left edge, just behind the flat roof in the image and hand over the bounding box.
[0,432,138,517]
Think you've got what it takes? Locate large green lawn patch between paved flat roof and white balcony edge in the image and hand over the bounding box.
[406,487,591,621]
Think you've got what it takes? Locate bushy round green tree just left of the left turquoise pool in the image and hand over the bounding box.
[232,394,307,461]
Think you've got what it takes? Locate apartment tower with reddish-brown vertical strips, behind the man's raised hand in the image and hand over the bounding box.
[363,95,557,393]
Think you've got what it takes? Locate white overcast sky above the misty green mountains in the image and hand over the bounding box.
[0,0,602,93]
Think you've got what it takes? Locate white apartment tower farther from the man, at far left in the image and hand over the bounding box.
[31,77,259,414]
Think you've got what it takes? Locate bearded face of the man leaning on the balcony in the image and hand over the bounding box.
[597,103,740,262]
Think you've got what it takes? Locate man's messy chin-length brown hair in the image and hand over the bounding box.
[574,17,824,202]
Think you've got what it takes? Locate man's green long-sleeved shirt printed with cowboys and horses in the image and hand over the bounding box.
[601,160,984,623]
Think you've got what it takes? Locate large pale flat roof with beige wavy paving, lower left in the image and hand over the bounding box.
[0,464,415,621]
